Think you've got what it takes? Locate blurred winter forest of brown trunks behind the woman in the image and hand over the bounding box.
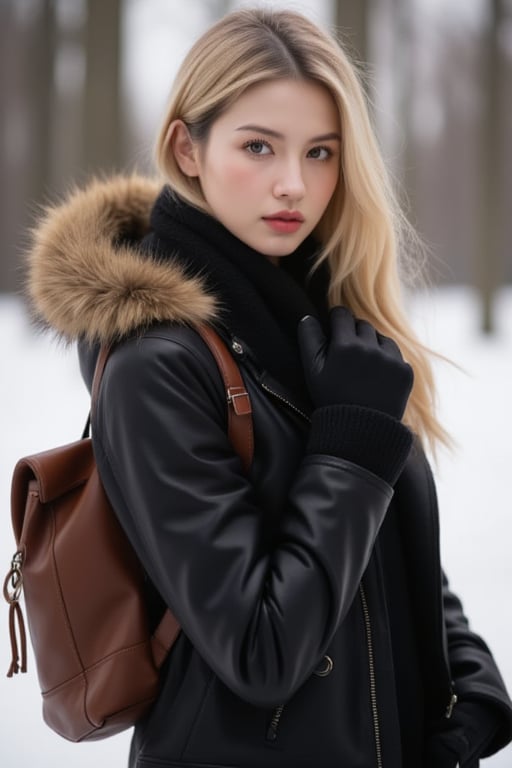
[0,0,512,331]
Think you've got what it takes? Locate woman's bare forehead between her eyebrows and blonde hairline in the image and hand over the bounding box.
[213,80,340,136]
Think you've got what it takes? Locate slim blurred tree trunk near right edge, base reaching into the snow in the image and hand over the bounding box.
[476,0,506,333]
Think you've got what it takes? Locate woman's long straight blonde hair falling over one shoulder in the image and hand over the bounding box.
[156,9,449,450]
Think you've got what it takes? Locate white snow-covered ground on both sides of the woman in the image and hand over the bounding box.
[0,288,512,768]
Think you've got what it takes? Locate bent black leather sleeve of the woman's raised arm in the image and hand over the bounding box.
[93,329,393,706]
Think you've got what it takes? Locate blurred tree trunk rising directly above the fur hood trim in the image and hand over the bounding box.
[83,0,124,173]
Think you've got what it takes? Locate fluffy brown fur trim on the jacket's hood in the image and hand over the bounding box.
[27,175,216,343]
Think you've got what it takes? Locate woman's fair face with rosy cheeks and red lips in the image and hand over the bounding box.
[175,80,341,261]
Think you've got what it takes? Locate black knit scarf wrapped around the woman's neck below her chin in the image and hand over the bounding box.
[144,187,328,402]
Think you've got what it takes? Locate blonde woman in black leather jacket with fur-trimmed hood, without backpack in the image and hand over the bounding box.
[30,10,512,768]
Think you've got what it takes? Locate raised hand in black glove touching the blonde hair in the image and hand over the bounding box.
[298,307,414,420]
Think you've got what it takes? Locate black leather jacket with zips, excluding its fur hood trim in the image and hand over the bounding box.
[79,326,510,768]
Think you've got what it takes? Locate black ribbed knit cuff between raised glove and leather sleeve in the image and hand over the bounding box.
[307,405,413,485]
